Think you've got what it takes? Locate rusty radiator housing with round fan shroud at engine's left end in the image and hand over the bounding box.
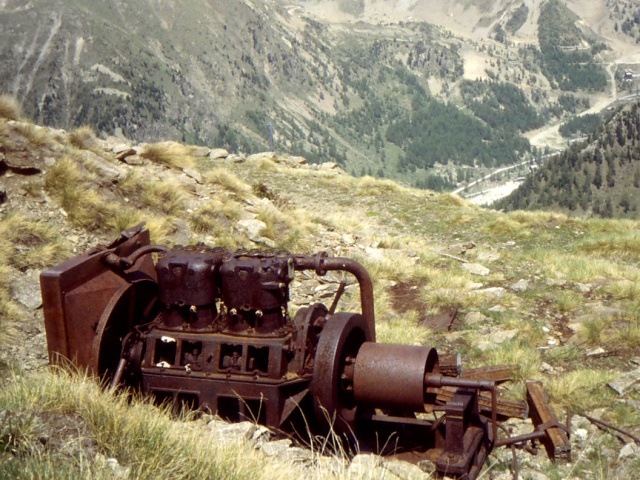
[40,225,156,376]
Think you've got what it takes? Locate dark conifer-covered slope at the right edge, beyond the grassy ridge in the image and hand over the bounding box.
[495,103,640,218]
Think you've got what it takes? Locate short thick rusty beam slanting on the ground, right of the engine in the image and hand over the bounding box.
[527,381,571,462]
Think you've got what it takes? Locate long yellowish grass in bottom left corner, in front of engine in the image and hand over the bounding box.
[0,371,310,480]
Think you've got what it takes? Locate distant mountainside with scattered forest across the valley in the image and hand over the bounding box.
[0,0,640,190]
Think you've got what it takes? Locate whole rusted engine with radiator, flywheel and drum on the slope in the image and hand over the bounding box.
[41,226,566,478]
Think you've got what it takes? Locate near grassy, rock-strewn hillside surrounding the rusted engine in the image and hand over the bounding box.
[0,99,640,479]
